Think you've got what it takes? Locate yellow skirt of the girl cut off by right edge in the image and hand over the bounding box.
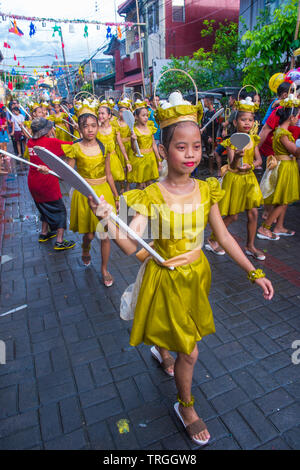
[264,159,300,205]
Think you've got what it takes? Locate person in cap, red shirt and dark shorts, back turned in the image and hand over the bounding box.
[27,117,76,251]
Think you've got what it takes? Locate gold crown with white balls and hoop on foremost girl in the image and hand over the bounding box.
[154,69,203,129]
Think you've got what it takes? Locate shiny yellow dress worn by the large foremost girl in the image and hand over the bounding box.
[123,178,224,354]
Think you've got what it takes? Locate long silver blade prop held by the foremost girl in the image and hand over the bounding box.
[34,146,174,270]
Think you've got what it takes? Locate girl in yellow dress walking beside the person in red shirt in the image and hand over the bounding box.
[62,108,119,287]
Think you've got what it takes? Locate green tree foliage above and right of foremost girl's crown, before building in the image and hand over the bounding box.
[159,20,246,94]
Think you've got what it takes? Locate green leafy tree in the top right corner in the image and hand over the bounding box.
[242,0,300,91]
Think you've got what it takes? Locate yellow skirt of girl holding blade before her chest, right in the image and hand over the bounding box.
[219,171,263,216]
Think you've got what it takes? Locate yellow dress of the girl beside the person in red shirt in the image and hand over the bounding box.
[62,142,116,233]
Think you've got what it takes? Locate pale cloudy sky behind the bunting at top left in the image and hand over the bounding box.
[0,0,124,71]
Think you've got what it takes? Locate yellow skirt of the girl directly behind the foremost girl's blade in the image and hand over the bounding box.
[70,182,116,233]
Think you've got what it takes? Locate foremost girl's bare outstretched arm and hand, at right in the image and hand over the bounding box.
[208,204,274,300]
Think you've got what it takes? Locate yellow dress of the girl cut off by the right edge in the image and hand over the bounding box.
[264,127,300,205]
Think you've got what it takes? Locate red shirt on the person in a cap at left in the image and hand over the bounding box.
[27,136,72,202]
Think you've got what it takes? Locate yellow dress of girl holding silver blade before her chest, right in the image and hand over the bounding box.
[219,135,263,216]
